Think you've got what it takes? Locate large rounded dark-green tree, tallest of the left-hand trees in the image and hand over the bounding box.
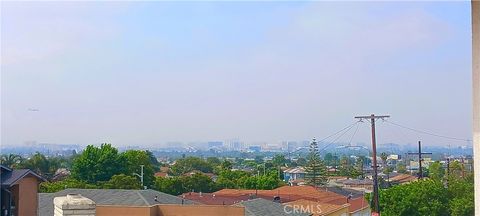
[71,143,127,183]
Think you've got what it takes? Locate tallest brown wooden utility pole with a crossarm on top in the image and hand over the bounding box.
[355,114,390,213]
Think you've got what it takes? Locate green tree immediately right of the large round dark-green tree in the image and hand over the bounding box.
[121,150,155,187]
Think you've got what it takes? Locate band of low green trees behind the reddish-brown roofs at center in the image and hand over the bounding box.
[153,157,284,195]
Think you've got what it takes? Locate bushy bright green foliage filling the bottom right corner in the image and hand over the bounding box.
[369,175,475,216]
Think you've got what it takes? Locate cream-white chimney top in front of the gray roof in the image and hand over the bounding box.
[53,194,96,216]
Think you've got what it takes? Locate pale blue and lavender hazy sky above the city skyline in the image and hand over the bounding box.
[1,1,471,146]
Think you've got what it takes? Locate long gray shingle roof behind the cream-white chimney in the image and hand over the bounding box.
[38,189,194,216]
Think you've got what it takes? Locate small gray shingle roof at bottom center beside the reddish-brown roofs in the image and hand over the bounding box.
[236,198,309,216]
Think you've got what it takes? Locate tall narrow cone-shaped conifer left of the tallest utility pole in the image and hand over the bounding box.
[305,139,327,187]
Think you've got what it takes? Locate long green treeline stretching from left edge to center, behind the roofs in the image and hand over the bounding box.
[1,144,285,195]
